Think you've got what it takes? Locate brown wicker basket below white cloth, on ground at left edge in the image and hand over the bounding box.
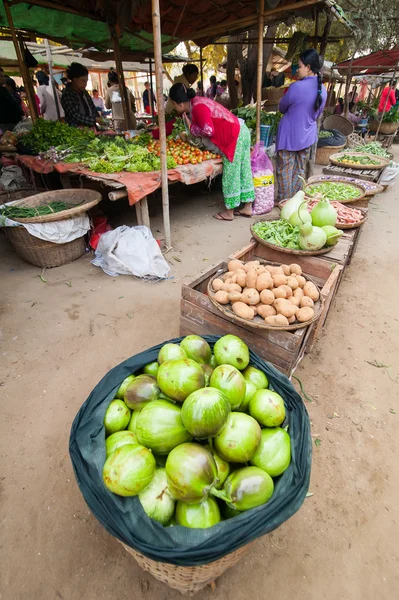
[5,226,86,268]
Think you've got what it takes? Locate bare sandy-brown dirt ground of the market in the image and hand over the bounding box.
[0,159,399,600]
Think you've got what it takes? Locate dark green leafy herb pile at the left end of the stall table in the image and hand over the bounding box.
[20,119,95,154]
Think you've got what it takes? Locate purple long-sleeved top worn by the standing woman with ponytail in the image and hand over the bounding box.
[276,77,327,152]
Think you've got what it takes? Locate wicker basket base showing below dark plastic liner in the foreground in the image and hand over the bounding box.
[121,542,251,596]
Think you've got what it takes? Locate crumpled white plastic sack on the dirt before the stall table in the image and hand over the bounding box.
[91,225,170,279]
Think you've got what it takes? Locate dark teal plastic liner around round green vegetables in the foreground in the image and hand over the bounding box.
[69,336,312,566]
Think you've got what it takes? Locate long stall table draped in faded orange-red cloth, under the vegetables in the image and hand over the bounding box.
[16,154,223,227]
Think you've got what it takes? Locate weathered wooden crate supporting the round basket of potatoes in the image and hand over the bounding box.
[180,252,342,376]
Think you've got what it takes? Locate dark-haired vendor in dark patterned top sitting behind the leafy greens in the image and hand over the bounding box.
[61,63,97,127]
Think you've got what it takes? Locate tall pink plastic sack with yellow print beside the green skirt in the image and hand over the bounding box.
[251,143,274,215]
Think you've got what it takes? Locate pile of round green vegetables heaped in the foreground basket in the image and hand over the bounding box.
[100,335,291,529]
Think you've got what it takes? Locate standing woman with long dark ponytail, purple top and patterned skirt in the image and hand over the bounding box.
[276,50,327,202]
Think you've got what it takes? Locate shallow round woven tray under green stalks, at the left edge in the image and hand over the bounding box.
[5,189,102,223]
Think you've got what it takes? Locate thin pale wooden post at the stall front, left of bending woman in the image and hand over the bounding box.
[152,0,172,249]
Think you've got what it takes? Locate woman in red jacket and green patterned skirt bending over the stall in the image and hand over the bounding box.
[169,83,255,221]
